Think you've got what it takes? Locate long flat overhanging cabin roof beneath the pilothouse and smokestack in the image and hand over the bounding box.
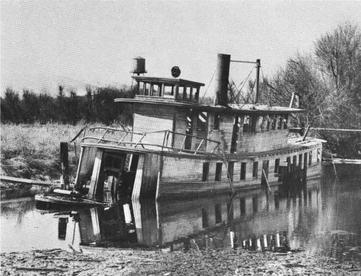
[114,96,304,114]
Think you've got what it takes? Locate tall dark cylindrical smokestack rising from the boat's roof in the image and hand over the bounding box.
[216,54,231,106]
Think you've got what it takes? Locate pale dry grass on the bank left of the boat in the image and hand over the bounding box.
[1,123,83,180]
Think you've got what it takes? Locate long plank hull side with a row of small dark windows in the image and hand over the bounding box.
[132,140,322,199]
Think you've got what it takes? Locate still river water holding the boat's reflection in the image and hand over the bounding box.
[1,167,361,260]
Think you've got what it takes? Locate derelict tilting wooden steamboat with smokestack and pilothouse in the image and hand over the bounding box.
[37,54,322,206]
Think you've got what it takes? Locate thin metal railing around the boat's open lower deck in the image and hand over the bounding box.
[81,127,220,155]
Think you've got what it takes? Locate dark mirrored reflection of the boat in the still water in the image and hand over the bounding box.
[52,177,322,250]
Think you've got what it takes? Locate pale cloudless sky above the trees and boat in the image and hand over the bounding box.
[0,0,361,97]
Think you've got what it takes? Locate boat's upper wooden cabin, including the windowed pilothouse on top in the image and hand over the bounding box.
[115,55,302,153]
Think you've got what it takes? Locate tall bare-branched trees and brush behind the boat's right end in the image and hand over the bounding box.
[263,23,361,158]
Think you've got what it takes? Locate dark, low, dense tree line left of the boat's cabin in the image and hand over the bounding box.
[1,85,133,125]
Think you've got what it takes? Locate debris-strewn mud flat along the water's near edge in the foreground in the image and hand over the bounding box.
[0,247,361,275]
